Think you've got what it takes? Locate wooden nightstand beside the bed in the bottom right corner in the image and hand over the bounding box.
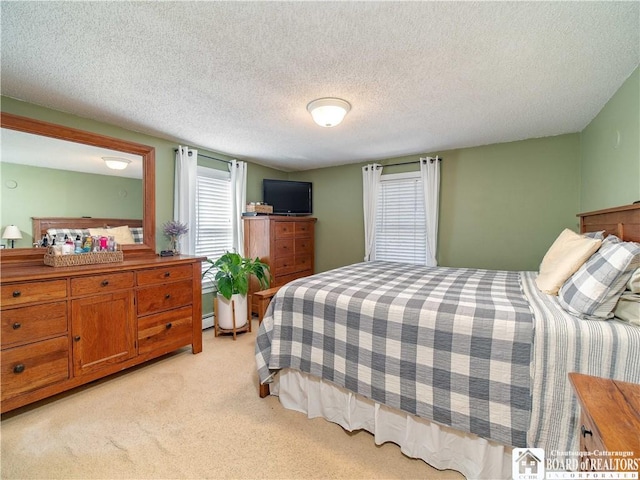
[569,372,640,471]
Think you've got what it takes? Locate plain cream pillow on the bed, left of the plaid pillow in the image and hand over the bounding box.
[536,228,602,295]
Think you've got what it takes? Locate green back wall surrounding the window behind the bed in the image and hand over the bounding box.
[290,134,580,271]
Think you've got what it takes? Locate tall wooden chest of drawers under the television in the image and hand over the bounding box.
[244,215,316,313]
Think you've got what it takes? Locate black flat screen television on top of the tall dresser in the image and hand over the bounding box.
[262,178,313,215]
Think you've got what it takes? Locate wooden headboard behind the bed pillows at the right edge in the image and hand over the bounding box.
[578,203,640,242]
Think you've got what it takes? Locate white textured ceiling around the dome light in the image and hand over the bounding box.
[0,1,640,170]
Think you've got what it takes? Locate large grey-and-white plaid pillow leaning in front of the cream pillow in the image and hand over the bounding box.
[558,235,640,320]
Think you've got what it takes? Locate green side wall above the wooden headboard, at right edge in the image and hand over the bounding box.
[580,68,640,212]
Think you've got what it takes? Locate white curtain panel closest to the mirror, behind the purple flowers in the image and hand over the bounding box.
[173,145,198,255]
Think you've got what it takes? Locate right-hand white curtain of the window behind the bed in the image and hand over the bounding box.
[420,157,440,267]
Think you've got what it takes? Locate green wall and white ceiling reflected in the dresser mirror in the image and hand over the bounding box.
[0,128,144,247]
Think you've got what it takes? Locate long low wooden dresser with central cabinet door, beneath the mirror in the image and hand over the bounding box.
[0,257,202,413]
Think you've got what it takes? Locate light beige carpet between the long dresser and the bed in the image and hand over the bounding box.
[0,320,463,479]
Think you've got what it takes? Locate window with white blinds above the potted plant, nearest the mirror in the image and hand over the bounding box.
[196,166,233,281]
